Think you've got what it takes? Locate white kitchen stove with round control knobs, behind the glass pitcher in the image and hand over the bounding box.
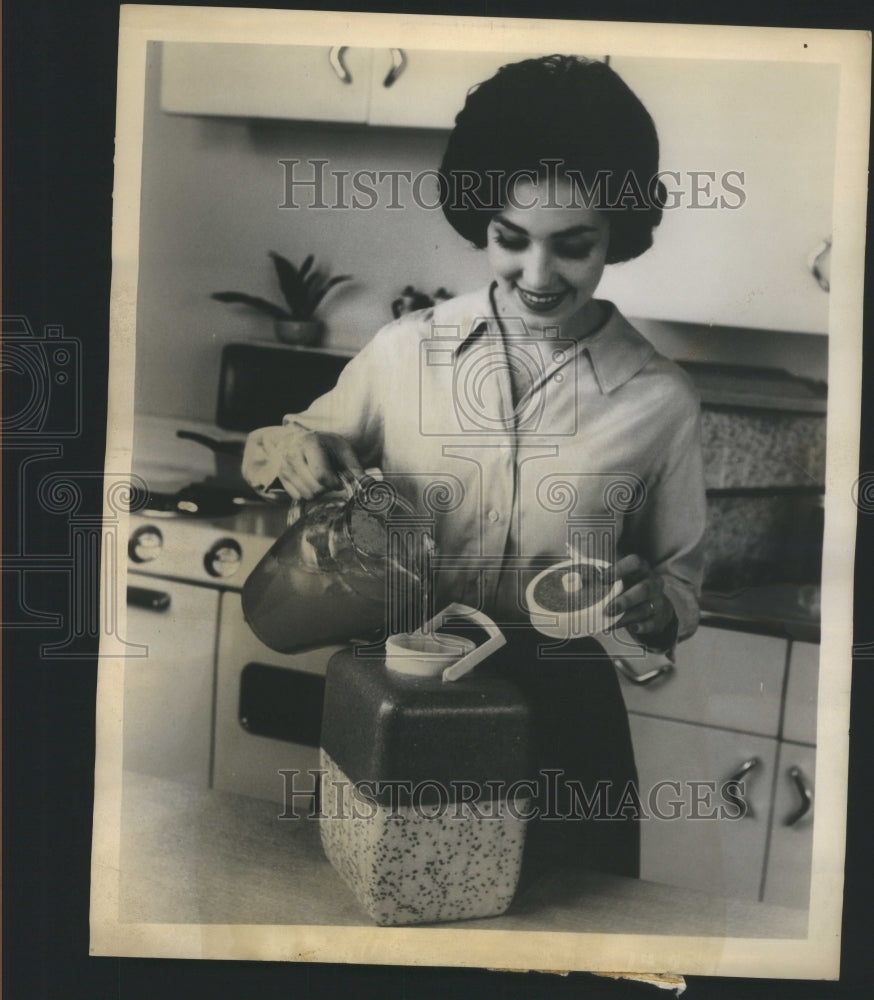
[123,418,340,807]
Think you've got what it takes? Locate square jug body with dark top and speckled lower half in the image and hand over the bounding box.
[320,650,530,925]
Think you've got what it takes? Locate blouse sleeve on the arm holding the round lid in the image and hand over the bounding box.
[623,382,707,641]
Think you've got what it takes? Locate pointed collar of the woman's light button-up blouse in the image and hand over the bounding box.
[432,285,655,395]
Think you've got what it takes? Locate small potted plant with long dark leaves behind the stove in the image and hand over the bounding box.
[212,250,350,344]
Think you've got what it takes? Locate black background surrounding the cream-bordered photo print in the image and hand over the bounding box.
[2,0,874,1000]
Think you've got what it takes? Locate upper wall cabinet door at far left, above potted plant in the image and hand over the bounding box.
[161,42,371,123]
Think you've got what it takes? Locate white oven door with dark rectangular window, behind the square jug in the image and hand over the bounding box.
[213,592,342,810]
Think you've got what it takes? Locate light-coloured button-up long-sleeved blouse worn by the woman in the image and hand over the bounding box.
[283,287,706,638]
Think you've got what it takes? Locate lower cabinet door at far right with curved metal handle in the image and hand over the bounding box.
[764,743,816,909]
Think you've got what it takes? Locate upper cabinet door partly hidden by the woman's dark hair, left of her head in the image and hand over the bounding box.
[368,48,544,129]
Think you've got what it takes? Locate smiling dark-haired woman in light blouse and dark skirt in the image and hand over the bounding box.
[244,56,704,875]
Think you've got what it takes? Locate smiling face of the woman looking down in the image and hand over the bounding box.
[487,179,610,329]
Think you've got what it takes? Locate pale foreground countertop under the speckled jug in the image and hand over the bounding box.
[119,772,807,938]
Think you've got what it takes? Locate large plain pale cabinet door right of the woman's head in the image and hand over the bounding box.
[600,57,839,333]
